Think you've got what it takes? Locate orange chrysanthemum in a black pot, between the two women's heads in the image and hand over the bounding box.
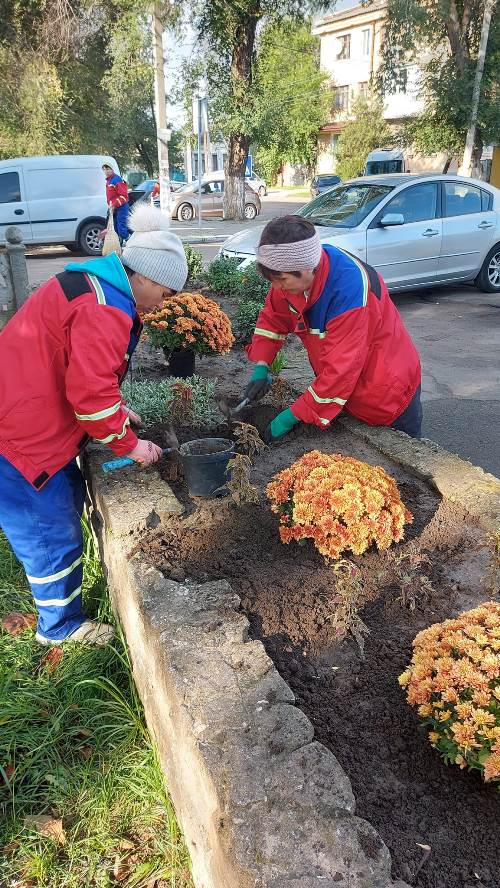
[144,293,234,379]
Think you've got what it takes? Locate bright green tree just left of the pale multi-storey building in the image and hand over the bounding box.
[253,19,331,180]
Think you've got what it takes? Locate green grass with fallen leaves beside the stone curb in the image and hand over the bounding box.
[0,533,192,888]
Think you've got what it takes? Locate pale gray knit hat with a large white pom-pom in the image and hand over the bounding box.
[121,202,188,292]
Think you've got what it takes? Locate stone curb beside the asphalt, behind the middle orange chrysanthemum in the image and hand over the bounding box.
[337,416,500,533]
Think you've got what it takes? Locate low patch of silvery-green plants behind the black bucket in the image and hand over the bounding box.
[121,376,222,429]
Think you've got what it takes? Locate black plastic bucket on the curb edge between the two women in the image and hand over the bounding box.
[179,438,234,497]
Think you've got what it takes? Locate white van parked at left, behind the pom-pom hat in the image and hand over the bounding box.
[0,154,119,256]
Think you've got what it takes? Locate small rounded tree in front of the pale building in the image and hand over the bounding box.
[336,96,392,179]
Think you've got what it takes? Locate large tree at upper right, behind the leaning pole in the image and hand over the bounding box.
[371,0,500,163]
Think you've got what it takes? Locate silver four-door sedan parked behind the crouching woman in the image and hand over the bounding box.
[219,174,500,293]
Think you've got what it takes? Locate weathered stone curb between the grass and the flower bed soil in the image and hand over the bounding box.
[85,451,408,888]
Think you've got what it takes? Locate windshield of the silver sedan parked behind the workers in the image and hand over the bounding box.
[297,183,394,228]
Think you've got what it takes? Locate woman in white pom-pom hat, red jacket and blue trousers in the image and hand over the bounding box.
[0,204,187,645]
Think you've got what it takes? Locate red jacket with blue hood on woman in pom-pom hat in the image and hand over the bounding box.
[0,253,142,490]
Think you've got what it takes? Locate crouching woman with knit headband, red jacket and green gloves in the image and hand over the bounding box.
[245,216,422,442]
